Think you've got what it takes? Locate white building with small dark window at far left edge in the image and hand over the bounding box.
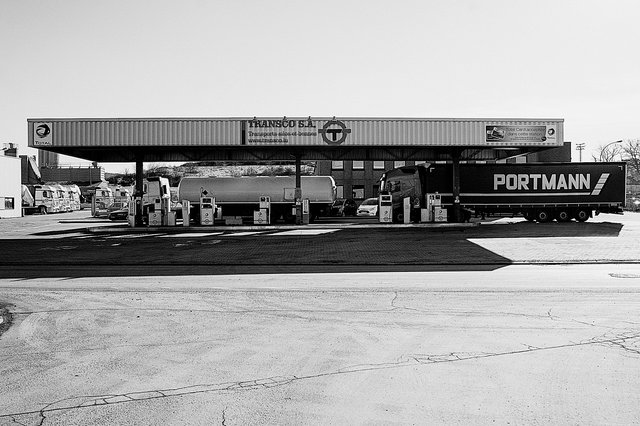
[0,144,22,219]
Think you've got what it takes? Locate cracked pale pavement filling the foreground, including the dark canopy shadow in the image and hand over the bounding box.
[0,213,640,425]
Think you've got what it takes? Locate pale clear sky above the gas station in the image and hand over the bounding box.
[0,0,640,172]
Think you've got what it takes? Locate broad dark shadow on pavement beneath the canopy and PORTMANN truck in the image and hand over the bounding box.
[0,222,622,279]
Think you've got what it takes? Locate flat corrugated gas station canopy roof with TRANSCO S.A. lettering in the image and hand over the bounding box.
[27,117,564,162]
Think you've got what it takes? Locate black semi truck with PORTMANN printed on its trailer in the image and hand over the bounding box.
[380,162,626,222]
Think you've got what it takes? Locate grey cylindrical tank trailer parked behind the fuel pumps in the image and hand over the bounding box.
[178,176,336,223]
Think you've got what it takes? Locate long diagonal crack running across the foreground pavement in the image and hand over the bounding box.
[0,331,640,425]
